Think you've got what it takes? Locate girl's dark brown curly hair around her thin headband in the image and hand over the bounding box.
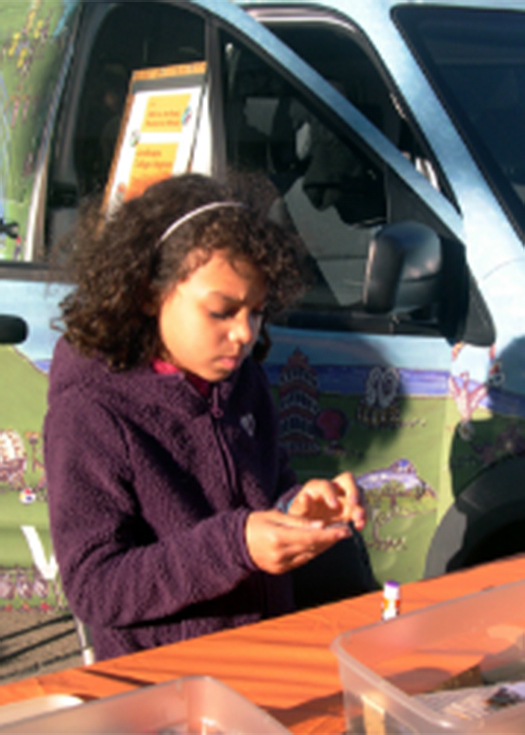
[57,174,305,370]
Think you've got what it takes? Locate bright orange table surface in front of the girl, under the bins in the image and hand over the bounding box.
[0,555,525,733]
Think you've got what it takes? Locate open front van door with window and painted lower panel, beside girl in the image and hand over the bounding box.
[211,11,494,581]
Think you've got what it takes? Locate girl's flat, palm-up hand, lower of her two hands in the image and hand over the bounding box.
[245,510,351,574]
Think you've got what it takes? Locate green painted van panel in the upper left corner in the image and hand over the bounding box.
[0,0,79,260]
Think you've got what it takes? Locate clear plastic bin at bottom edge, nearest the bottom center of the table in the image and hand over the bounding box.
[0,676,290,735]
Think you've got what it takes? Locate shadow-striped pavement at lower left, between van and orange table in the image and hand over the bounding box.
[0,609,82,686]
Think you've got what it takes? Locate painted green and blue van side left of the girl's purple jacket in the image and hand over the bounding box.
[0,281,67,612]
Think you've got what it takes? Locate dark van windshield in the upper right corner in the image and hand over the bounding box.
[394,6,525,235]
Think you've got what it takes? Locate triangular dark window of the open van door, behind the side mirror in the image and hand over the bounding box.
[221,34,452,334]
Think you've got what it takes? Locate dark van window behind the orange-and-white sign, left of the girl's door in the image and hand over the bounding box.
[46,2,205,249]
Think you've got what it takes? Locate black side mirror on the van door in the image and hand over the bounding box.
[363,221,442,314]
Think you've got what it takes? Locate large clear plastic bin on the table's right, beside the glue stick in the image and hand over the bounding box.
[331,582,525,735]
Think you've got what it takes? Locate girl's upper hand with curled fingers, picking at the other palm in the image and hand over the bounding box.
[288,472,366,531]
